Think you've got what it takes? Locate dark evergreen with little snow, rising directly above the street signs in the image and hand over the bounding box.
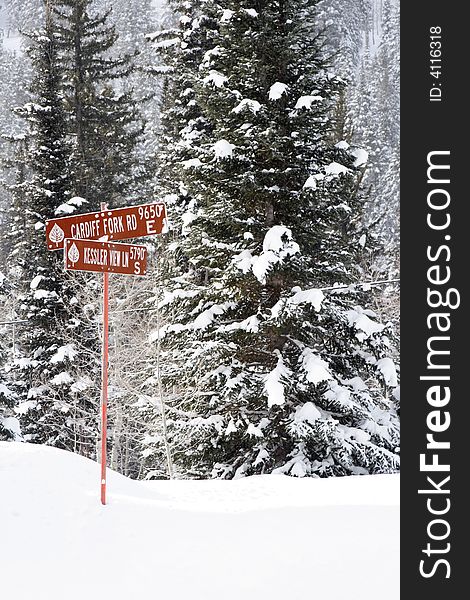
[53,0,145,207]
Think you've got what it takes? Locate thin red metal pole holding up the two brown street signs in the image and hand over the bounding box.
[101,203,109,505]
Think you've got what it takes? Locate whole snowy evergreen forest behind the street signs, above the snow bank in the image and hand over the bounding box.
[0,0,399,478]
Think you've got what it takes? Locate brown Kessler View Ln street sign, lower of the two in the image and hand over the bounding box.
[64,239,147,275]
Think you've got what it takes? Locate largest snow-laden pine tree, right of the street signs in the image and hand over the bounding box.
[154,0,398,478]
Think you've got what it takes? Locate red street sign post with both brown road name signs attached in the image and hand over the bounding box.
[46,202,171,505]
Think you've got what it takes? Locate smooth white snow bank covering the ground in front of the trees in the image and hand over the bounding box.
[0,443,399,600]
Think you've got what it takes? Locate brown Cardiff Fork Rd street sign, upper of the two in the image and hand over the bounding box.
[46,202,166,250]
